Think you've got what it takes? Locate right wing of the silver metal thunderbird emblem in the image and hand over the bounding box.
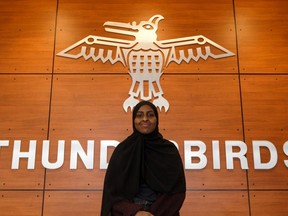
[157,35,235,66]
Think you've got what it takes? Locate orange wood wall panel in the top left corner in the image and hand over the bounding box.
[0,0,56,73]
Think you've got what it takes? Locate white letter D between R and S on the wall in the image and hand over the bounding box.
[252,140,278,169]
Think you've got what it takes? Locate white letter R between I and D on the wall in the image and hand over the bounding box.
[225,141,248,169]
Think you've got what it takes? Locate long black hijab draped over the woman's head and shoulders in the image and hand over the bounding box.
[101,101,186,216]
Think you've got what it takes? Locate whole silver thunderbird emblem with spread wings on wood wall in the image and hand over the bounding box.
[57,15,234,112]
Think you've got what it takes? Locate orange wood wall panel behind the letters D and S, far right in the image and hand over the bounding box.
[241,75,288,189]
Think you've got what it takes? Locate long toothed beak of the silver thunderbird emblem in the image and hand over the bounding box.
[103,21,138,36]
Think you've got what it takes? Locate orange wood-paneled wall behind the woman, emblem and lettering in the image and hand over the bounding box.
[0,0,288,216]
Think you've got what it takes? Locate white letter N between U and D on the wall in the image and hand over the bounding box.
[70,140,94,169]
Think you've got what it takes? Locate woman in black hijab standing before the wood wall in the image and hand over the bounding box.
[101,101,186,216]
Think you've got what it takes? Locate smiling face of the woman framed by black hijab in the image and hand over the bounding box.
[134,105,157,134]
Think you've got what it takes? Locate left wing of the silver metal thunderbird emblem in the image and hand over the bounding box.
[57,35,136,66]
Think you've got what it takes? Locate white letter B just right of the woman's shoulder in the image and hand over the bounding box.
[184,140,207,169]
